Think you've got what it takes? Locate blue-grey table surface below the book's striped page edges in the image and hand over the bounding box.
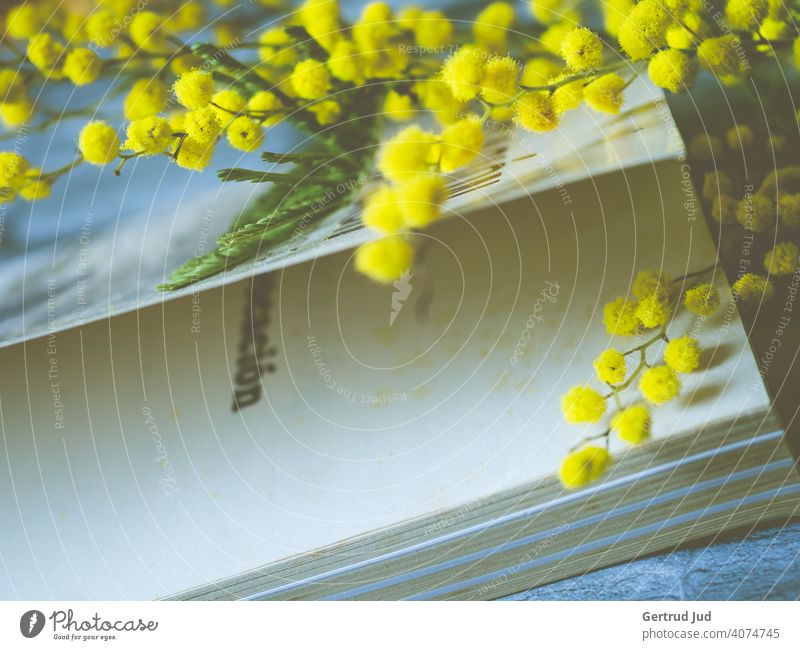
[504,519,800,600]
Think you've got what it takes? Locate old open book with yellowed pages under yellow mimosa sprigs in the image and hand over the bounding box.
[0,81,800,599]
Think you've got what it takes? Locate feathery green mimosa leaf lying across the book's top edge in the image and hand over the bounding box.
[158,39,385,291]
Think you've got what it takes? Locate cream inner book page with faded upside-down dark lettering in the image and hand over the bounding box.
[0,152,768,599]
